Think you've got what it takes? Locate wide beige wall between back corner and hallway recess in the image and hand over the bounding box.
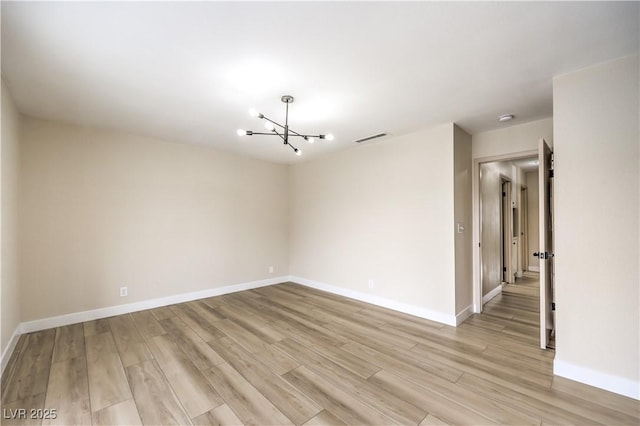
[290,124,455,315]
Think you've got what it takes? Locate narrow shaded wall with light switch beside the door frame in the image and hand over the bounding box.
[453,126,473,314]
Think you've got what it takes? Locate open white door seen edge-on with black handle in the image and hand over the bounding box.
[534,139,554,349]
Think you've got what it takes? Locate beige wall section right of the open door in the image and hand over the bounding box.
[553,55,640,398]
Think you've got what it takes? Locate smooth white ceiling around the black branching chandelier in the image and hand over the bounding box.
[1,1,640,163]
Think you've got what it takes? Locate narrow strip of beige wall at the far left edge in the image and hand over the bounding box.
[0,82,21,358]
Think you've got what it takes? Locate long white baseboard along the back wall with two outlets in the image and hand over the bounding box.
[20,276,289,333]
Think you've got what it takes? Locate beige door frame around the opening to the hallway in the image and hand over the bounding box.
[471,149,538,314]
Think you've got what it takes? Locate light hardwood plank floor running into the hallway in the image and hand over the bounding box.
[2,278,640,425]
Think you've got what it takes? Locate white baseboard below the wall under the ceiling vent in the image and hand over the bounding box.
[289,276,458,327]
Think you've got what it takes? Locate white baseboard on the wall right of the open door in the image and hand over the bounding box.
[553,359,640,400]
